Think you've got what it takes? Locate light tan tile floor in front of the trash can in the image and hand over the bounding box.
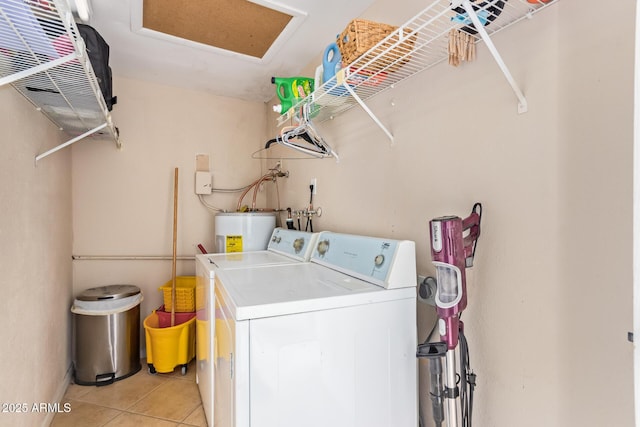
[51,360,207,427]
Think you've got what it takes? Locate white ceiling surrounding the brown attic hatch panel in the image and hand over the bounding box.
[89,0,374,102]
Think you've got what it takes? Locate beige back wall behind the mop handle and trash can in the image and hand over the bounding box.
[72,78,266,332]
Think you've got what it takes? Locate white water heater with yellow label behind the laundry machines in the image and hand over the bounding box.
[215,212,276,253]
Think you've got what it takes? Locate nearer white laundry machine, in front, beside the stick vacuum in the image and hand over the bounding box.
[198,232,418,427]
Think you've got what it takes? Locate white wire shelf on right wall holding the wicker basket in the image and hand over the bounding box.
[278,0,559,142]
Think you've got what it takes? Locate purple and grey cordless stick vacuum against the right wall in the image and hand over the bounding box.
[417,203,482,427]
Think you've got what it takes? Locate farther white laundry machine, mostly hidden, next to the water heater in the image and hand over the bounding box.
[196,228,317,425]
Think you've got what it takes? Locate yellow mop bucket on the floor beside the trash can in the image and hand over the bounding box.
[144,311,196,375]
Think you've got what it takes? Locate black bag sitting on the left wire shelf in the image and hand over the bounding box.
[77,24,118,111]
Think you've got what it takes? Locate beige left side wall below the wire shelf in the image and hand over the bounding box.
[0,86,72,427]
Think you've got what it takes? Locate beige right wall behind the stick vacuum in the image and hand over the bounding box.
[262,0,634,427]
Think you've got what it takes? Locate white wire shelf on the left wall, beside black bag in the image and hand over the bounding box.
[0,0,121,162]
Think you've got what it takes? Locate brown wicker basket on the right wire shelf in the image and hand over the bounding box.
[336,19,417,73]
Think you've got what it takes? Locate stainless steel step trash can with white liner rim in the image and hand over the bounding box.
[71,285,142,386]
